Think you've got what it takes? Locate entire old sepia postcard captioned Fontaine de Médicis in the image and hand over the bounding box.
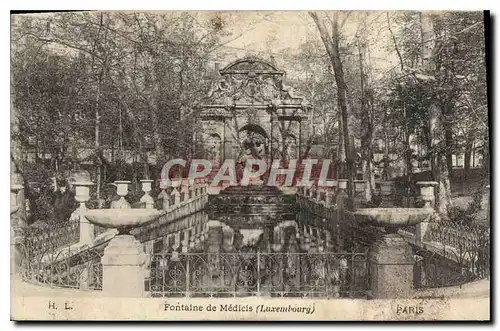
[10,11,491,321]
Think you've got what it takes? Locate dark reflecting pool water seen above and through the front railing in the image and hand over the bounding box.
[145,211,367,297]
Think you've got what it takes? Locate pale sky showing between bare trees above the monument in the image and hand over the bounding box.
[203,11,397,78]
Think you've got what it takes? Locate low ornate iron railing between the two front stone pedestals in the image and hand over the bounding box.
[146,252,368,298]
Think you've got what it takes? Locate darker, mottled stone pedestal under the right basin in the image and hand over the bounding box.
[368,233,414,299]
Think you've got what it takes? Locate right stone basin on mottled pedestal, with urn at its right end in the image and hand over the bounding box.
[354,182,436,299]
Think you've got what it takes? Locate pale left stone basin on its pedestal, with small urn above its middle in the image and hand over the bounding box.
[85,182,161,297]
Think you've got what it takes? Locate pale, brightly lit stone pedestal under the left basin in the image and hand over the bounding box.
[101,235,148,298]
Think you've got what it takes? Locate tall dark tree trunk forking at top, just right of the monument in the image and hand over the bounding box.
[309,12,355,202]
